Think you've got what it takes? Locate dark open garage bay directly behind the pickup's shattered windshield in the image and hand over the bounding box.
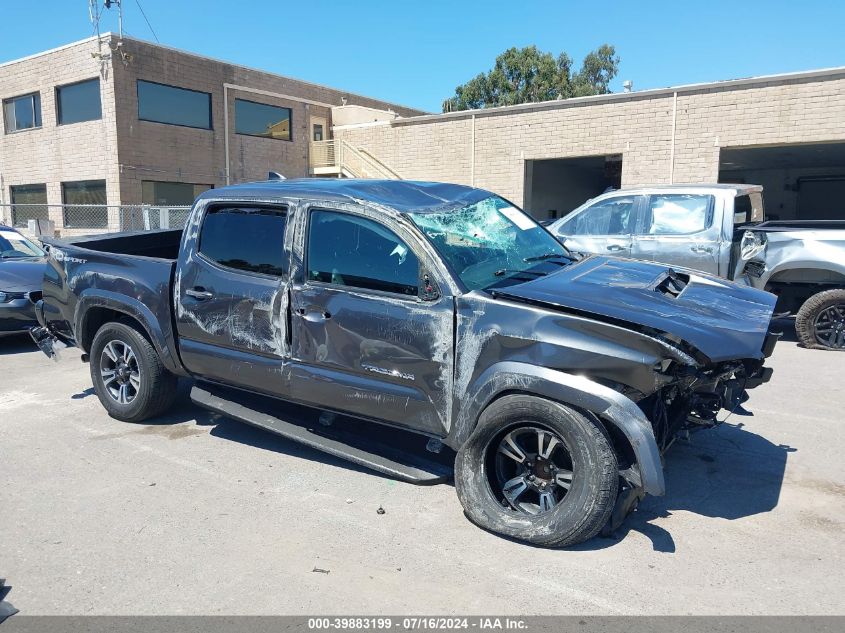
[524,154,622,220]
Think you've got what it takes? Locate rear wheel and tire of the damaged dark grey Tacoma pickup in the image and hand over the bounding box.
[90,323,178,422]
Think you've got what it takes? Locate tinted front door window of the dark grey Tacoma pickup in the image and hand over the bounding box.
[307,211,420,296]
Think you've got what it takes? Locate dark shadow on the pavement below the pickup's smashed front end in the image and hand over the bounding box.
[569,422,797,553]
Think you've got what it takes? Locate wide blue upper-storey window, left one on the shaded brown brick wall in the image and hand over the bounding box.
[138,79,211,130]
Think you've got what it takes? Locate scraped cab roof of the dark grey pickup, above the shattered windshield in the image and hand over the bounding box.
[199,178,493,213]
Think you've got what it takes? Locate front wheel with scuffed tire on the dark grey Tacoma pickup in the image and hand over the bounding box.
[455,395,619,547]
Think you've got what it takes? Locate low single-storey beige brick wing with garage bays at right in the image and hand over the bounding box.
[334,68,845,219]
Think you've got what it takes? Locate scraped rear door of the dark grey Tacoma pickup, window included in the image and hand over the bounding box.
[174,203,289,395]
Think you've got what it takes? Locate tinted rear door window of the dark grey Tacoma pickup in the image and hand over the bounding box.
[199,207,287,276]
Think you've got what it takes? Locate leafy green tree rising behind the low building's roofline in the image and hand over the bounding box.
[443,44,619,112]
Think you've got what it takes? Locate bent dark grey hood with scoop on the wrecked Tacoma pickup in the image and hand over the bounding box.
[496,257,777,362]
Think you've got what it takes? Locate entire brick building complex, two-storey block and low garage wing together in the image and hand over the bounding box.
[0,34,845,233]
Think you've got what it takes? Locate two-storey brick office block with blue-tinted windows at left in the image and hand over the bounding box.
[0,34,421,231]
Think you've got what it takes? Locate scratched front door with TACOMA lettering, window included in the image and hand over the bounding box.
[291,209,453,435]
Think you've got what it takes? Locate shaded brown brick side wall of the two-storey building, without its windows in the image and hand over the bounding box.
[114,38,420,203]
